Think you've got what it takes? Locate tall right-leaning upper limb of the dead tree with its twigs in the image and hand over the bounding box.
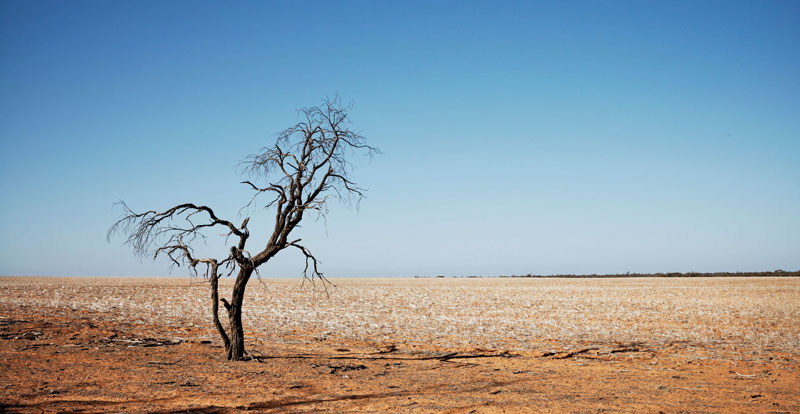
[243,97,380,268]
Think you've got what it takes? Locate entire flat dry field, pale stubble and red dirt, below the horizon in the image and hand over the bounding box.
[0,277,800,413]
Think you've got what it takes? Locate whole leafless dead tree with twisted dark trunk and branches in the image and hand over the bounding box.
[108,98,378,361]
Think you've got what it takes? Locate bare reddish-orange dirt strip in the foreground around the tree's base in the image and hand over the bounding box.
[0,306,800,413]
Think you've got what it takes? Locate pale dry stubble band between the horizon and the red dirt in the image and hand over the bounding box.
[0,277,800,354]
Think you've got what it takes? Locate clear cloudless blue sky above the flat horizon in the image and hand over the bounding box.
[0,0,800,277]
